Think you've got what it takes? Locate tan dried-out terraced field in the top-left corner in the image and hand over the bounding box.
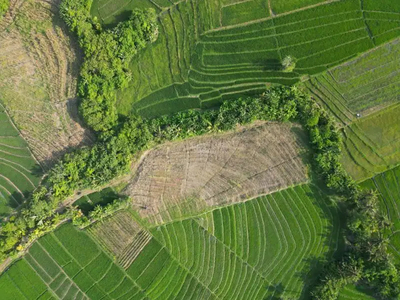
[0,0,92,169]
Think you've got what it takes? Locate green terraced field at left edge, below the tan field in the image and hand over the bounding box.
[0,104,42,220]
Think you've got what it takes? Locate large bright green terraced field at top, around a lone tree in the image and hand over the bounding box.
[92,0,400,116]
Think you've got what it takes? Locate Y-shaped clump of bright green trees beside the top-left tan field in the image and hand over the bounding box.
[60,0,158,132]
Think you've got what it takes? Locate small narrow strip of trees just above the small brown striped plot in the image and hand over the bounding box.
[68,197,132,229]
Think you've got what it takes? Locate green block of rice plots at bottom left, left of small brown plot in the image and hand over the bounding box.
[25,224,148,299]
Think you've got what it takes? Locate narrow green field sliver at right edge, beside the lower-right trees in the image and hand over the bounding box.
[361,167,400,263]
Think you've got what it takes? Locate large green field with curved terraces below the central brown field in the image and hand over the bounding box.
[153,185,340,299]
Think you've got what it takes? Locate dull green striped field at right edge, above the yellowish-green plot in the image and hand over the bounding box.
[307,37,400,126]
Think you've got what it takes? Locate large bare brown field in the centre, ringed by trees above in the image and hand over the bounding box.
[123,123,307,224]
